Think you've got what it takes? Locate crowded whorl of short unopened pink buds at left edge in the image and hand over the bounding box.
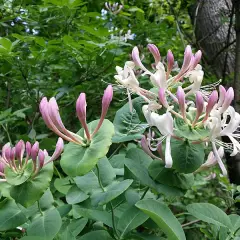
[0,138,64,182]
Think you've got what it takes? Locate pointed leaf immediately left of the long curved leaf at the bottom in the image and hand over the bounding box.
[117,206,149,239]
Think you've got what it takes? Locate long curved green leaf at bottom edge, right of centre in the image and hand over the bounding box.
[136,199,186,240]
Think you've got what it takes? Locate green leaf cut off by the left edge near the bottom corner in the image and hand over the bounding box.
[0,199,27,232]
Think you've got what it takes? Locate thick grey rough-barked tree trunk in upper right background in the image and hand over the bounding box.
[190,0,235,81]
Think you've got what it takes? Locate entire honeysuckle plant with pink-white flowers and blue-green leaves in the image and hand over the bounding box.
[0,44,240,240]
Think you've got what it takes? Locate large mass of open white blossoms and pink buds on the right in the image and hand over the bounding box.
[115,44,240,175]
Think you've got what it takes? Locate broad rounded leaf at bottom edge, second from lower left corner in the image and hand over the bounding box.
[27,208,62,240]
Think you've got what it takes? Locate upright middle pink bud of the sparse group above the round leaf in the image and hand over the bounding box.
[76,93,91,140]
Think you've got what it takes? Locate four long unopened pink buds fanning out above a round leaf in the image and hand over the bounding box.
[39,85,113,146]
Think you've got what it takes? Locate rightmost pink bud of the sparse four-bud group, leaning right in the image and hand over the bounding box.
[92,85,113,136]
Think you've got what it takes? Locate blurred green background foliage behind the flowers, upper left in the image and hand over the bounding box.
[0,0,192,149]
